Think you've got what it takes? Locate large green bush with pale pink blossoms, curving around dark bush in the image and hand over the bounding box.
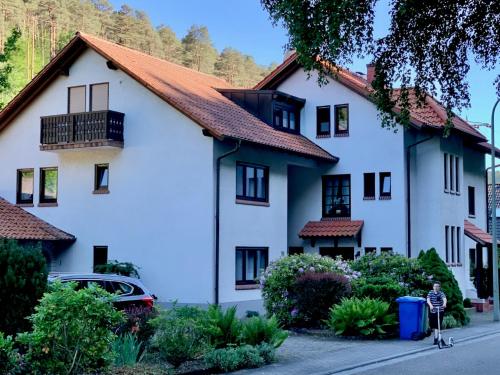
[260,254,358,326]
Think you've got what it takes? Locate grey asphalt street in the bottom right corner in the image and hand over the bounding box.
[350,334,500,375]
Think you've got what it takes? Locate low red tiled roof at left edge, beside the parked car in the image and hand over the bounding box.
[0,197,76,241]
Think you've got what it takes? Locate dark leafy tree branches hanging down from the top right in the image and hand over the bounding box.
[261,0,500,128]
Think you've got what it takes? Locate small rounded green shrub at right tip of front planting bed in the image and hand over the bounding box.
[241,316,288,348]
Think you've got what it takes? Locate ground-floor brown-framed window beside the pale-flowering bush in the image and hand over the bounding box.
[235,247,269,285]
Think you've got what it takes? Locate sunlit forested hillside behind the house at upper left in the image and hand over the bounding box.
[0,0,274,104]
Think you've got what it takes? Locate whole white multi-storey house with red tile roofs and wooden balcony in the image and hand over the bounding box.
[0,34,491,311]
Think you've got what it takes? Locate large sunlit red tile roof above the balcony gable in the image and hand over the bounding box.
[0,33,338,161]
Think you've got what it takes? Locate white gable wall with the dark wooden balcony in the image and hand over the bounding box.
[0,50,214,303]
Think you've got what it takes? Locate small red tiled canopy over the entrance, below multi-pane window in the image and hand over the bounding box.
[299,220,364,238]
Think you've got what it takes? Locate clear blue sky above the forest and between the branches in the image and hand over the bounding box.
[111,0,500,137]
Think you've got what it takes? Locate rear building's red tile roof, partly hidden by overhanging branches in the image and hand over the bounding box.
[255,53,486,141]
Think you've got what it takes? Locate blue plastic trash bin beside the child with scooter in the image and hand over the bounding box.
[396,296,425,340]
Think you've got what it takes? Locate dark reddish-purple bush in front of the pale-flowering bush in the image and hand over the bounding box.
[291,272,351,327]
